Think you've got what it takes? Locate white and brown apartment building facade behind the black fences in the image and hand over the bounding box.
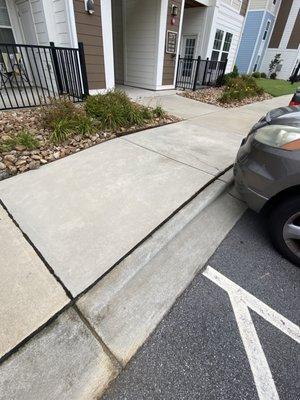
[0,0,247,94]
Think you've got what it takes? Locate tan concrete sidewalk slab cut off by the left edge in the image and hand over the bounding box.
[0,207,69,358]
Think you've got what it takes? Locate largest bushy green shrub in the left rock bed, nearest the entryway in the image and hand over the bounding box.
[85,90,154,130]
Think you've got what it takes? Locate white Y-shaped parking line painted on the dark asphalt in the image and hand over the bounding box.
[203,266,300,400]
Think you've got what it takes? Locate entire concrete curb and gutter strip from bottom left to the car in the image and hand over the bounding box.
[0,177,245,400]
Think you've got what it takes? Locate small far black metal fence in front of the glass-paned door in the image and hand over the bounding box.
[176,57,227,90]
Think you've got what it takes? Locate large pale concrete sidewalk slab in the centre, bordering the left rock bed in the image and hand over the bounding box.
[0,138,212,295]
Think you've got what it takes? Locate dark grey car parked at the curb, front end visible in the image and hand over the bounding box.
[234,106,300,266]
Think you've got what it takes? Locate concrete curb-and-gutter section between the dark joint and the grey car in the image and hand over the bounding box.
[78,182,246,365]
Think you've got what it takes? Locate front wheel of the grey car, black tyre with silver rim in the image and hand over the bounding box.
[269,196,300,266]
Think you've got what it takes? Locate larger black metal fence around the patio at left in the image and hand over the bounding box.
[0,43,89,110]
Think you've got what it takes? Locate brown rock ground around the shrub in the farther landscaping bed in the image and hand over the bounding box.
[180,87,272,108]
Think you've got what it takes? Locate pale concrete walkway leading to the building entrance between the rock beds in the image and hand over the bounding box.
[137,94,220,119]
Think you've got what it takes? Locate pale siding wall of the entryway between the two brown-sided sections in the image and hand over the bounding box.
[124,0,160,89]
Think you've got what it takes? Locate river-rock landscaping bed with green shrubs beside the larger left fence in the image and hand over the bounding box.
[0,92,179,180]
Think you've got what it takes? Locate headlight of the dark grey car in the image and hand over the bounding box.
[254,125,300,151]
